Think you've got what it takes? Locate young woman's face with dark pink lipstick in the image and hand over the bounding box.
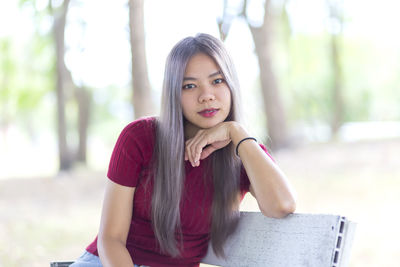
[181,53,231,137]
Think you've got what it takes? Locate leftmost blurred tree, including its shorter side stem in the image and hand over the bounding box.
[20,0,90,171]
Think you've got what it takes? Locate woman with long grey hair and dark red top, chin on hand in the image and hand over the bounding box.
[72,34,295,267]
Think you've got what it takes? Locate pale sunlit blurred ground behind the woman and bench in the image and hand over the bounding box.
[0,139,400,267]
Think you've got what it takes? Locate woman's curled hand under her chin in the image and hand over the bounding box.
[185,122,231,167]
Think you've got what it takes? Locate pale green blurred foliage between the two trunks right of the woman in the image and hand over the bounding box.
[277,35,332,124]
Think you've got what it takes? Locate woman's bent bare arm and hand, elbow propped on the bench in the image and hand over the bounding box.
[185,121,296,218]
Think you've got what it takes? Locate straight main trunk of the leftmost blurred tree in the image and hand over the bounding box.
[53,0,72,171]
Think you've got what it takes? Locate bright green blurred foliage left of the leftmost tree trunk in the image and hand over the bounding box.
[0,0,55,138]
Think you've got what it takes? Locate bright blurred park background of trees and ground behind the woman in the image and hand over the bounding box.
[0,0,400,267]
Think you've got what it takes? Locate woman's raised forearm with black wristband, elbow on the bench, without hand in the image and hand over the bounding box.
[230,122,296,218]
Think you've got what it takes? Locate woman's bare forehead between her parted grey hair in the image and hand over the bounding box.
[185,53,220,76]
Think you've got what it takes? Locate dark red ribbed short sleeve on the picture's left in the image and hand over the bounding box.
[107,120,152,187]
